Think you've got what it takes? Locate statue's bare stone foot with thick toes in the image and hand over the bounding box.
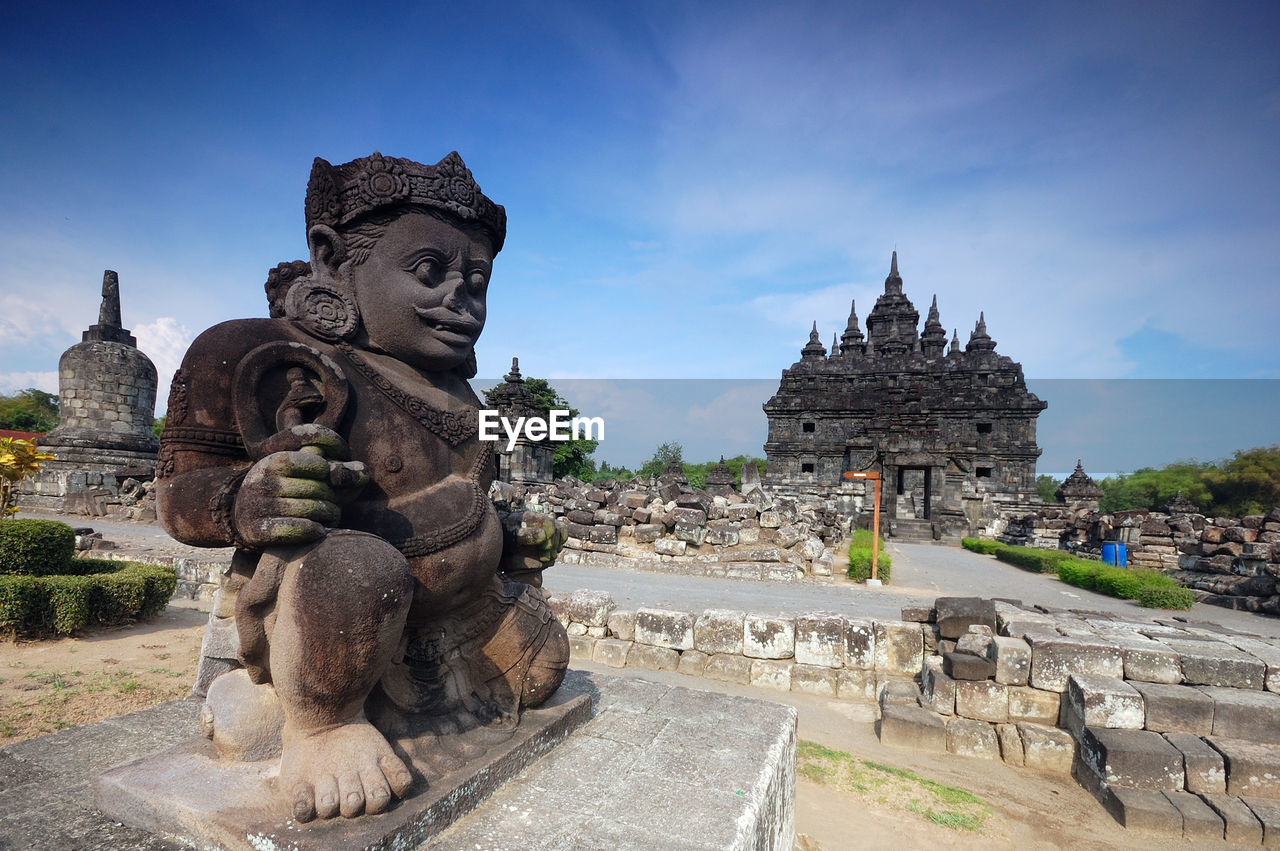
[280,719,413,822]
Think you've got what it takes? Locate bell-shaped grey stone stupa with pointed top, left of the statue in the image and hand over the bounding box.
[23,269,160,508]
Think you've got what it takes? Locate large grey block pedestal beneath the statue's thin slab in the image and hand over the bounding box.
[0,671,796,851]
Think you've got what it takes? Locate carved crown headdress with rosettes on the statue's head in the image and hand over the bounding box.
[307,151,507,252]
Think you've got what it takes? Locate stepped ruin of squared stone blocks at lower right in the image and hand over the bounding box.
[881,598,1280,845]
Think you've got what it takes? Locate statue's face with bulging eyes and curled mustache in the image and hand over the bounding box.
[351,212,493,371]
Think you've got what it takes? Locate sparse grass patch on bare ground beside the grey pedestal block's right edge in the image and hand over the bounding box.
[796,740,991,832]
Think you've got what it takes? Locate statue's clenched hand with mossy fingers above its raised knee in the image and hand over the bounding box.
[233,449,342,546]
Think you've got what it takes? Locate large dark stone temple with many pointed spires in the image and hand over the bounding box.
[764,251,1047,539]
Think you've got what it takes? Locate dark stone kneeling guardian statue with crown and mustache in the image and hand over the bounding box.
[157,152,568,822]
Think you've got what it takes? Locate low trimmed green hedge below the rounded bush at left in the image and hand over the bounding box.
[0,560,178,637]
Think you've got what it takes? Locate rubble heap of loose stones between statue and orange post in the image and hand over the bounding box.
[492,462,849,580]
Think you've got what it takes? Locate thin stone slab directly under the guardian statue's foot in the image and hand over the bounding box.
[95,688,591,851]
